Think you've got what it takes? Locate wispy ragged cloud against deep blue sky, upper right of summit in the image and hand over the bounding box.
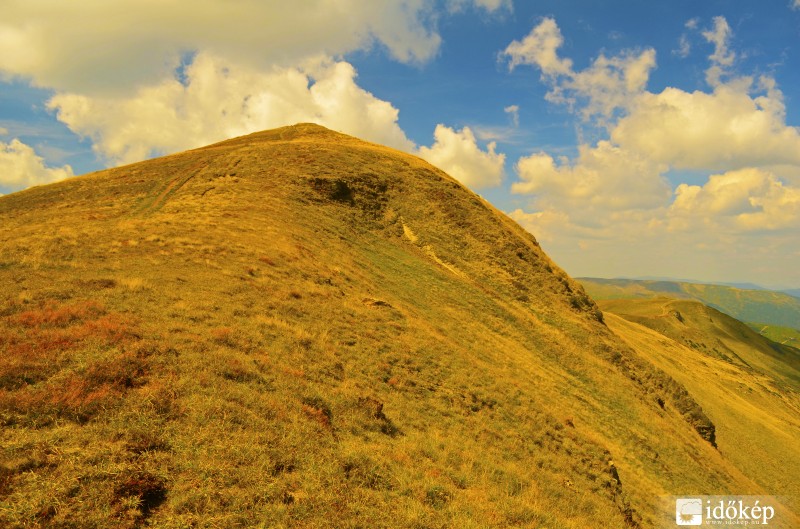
[503,18,656,119]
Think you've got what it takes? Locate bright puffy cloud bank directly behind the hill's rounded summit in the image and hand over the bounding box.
[49,53,414,163]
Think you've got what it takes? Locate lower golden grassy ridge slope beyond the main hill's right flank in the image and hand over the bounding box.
[601,298,800,512]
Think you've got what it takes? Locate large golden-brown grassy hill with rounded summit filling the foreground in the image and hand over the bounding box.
[0,124,796,528]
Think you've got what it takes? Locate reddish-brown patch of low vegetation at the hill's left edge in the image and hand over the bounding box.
[0,300,149,423]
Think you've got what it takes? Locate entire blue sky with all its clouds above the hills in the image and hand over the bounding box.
[0,0,800,287]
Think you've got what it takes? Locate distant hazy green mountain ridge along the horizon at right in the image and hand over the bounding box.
[578,277,800,329]
